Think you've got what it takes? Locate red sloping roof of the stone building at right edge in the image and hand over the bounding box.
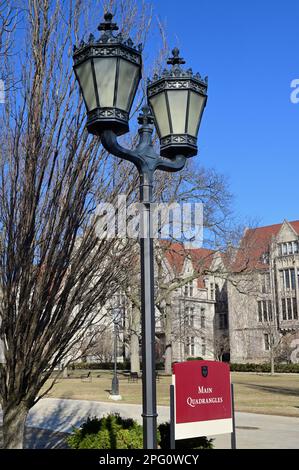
[233,220,299,272]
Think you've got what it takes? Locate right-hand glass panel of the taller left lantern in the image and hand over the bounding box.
[116,59,139,112]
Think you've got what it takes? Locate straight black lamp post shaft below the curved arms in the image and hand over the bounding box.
[140,171,158,449]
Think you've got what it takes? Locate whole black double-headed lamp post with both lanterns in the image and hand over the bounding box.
[73,13,207,449]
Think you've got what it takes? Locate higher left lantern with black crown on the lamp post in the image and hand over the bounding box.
[73,12,142,135]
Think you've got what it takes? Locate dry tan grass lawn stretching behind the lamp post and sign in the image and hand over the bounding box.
[41,371,299,417]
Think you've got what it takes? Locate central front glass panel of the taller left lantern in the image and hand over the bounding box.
[94,57,116,108]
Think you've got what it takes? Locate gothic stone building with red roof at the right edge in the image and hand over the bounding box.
[228,221,299,362]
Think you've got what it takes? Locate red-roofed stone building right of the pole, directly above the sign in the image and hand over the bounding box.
[156,243,229,361]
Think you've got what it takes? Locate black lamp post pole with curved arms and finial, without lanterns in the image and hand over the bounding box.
[101,114,186,449]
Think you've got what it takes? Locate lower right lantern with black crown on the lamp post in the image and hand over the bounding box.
[147,47,208,157]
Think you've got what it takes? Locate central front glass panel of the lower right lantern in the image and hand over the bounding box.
[167,90,188,134]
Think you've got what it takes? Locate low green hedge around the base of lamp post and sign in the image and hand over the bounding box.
[67,414,213,449]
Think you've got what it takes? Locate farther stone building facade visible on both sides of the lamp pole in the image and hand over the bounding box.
[95,243,229,362]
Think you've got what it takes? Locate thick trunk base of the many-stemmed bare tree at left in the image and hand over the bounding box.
[3,402,29,449]
